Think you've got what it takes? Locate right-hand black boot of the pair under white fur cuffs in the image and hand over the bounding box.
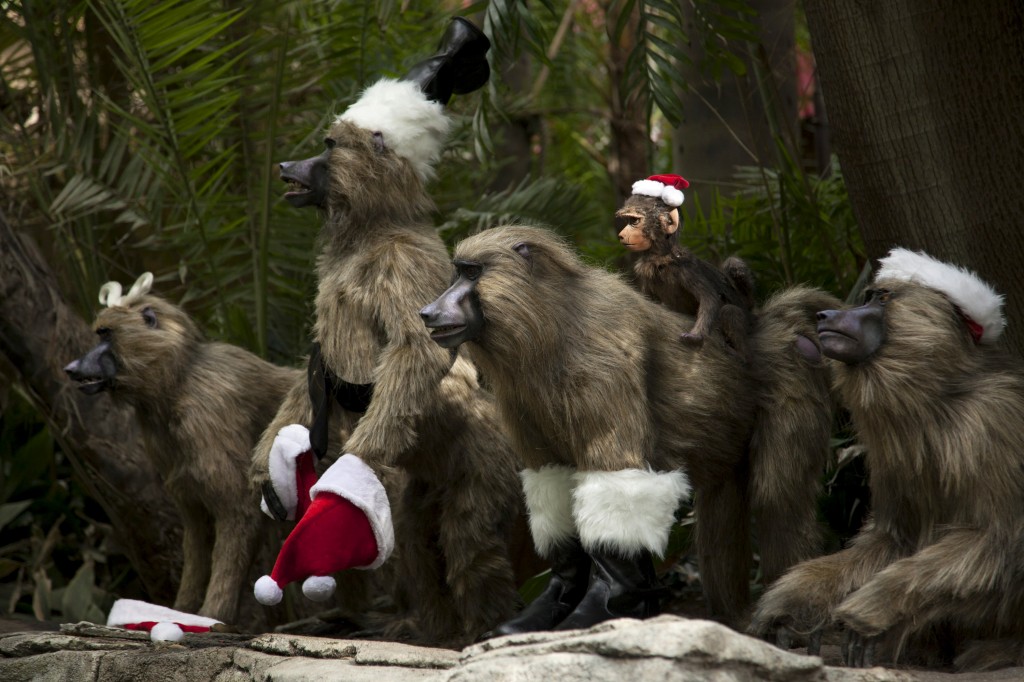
[555,551,664,630]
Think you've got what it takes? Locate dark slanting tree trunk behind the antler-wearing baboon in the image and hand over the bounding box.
[0,208,181,603]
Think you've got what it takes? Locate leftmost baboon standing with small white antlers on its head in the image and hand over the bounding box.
[65,272,302,624]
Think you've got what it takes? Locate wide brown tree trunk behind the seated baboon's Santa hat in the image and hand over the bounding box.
[806,0,1024,353]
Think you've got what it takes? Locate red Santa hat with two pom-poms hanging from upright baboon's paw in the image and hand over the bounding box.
[253,455,394,606]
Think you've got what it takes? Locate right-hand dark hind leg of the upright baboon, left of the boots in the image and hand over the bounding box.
[439,477,518,643]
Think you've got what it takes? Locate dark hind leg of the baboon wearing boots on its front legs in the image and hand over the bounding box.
[693,471,752,624]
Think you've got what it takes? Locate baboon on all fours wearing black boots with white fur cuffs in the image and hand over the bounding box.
[420,226,835,635]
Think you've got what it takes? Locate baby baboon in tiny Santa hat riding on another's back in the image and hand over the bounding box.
[615,175,754,359]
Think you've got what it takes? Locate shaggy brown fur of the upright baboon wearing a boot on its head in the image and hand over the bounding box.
[253,121,521,645]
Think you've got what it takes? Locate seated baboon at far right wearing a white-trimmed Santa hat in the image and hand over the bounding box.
[751,249,1024,667]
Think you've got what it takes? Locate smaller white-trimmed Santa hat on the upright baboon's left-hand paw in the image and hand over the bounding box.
[259,424,316,521]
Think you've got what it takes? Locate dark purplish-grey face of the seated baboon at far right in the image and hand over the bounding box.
[817,289,892,365]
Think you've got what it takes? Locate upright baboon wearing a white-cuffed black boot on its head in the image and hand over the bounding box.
[246,15,521,645]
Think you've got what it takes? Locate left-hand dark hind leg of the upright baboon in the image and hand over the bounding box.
[385,477,457,643]
